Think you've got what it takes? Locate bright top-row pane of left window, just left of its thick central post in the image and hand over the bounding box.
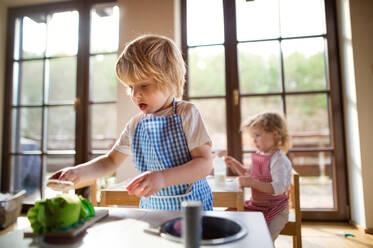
[47,11,79,56]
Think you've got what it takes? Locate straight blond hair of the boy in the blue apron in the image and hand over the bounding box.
[116,35,186,99]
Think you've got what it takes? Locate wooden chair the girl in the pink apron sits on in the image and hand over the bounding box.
[280,169,302,248]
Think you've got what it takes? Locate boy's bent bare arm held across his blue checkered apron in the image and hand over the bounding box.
[127,143,213,196]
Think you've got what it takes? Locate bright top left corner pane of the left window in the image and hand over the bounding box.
[20,14,47,58]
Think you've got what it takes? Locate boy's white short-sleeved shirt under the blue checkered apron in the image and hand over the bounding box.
[114,101,212,155]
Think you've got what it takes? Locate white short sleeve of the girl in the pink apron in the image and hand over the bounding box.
[259,150,292,195]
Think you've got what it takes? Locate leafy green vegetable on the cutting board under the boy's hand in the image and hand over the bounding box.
[27,194,95,235]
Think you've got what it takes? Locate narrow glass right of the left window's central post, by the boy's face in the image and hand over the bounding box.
[89,5,119,157]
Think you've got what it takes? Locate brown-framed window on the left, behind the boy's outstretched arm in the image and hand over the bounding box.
[2,1,119,203]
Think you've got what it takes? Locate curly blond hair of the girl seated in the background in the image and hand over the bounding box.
[241,112,291,153]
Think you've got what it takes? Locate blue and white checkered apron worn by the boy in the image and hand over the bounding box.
[132,100,212,210]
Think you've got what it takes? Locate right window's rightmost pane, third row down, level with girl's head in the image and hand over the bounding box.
[286,94,331,148]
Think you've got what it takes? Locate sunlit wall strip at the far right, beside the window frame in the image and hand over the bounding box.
[337,0,373,229]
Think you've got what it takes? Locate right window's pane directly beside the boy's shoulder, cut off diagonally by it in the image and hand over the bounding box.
[191,99,227,150]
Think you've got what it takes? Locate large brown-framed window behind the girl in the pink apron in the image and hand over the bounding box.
[182,0,347,219]
